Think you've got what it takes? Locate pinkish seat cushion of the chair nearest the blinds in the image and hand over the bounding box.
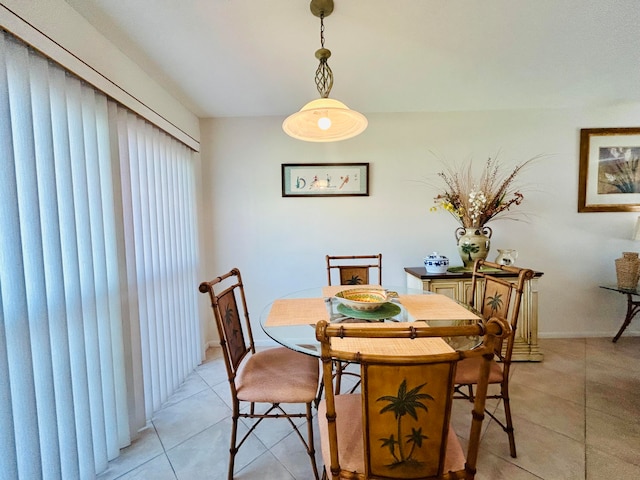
[236,347,320,403]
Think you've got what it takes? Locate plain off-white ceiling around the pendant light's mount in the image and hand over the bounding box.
[66,0,640,117]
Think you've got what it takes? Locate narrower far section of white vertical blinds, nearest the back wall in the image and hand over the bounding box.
[110,103,200,415]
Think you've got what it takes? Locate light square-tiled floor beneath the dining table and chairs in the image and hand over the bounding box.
[98,336,640,480]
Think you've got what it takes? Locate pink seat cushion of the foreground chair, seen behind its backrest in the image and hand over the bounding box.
[318,394,465,474]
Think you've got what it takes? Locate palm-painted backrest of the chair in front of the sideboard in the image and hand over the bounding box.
[469,260,534,362]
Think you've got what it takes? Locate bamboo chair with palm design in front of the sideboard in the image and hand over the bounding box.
[456,260,534,458]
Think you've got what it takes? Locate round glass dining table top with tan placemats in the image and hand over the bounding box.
[260,285,482,357]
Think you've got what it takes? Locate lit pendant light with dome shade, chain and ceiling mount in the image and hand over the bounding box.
[282,0,368,142]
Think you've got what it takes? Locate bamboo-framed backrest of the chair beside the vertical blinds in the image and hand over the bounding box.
[199,268,255,388]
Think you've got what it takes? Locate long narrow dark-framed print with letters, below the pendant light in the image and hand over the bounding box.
[282,163,369,197]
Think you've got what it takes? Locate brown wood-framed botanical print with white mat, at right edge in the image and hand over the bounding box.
[578,127,640,212]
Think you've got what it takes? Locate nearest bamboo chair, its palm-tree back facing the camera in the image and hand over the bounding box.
[316,318,510,480]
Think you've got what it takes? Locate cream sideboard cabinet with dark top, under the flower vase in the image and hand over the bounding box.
[404,267,543,362]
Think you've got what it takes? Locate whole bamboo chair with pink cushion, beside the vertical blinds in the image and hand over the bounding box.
[199,268,320,480]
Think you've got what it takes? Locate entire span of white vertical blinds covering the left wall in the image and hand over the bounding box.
[0,31,200,479]
